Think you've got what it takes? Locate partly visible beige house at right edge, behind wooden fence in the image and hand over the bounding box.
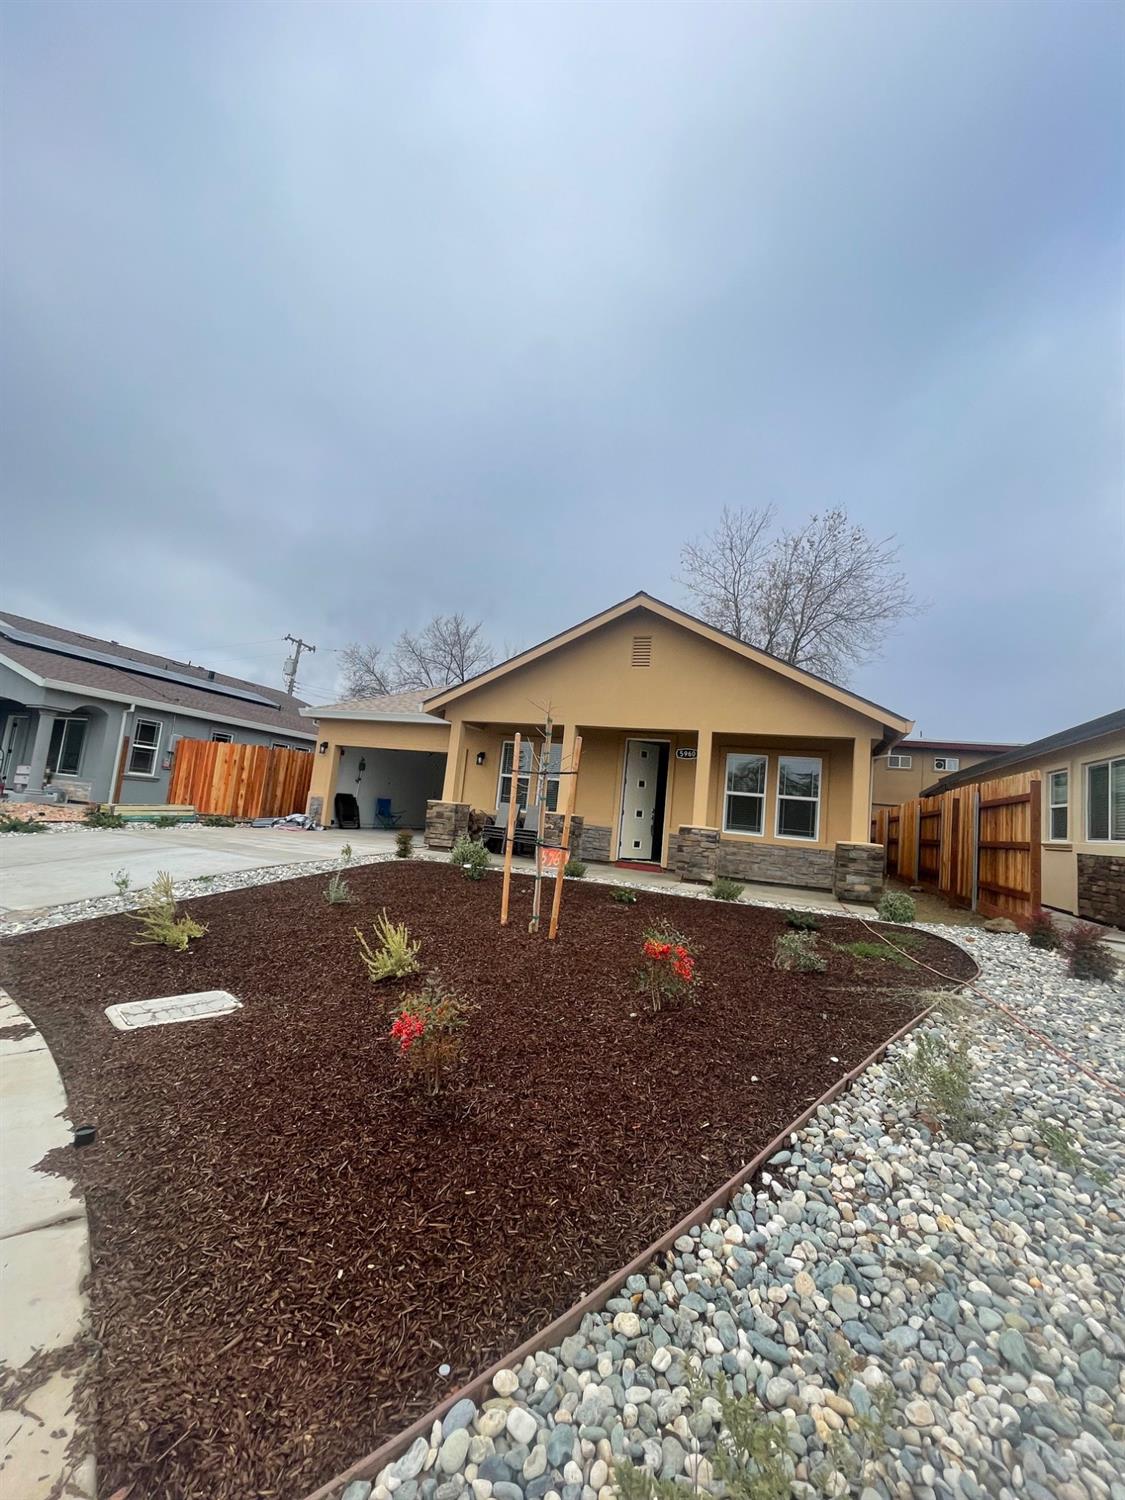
[926,708,1125,927]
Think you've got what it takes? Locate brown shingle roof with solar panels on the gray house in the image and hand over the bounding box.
[0,612,314,740]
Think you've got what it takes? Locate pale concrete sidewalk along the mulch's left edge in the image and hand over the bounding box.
[0,990,95,1500]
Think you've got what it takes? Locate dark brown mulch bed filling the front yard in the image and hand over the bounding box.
[0,863,974,1500]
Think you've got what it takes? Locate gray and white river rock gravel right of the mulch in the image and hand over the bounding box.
[366,926,1125,1500]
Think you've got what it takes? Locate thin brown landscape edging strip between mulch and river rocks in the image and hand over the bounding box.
[305,939,981,1500]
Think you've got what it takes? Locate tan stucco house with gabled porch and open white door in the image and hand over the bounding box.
[305,593,912,893]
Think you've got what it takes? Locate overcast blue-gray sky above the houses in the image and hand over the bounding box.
[0,0,1125,740]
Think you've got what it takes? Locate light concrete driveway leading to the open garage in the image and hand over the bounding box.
[0,825,402,918]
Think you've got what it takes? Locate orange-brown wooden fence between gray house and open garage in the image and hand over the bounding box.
[168,740,312,818]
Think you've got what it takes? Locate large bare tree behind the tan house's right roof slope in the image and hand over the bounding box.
[681,510,920,678]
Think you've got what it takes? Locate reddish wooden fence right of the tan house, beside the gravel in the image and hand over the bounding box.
[872,771,1043,917]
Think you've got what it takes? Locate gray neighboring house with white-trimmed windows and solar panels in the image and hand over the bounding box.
[0,614,315,803]
